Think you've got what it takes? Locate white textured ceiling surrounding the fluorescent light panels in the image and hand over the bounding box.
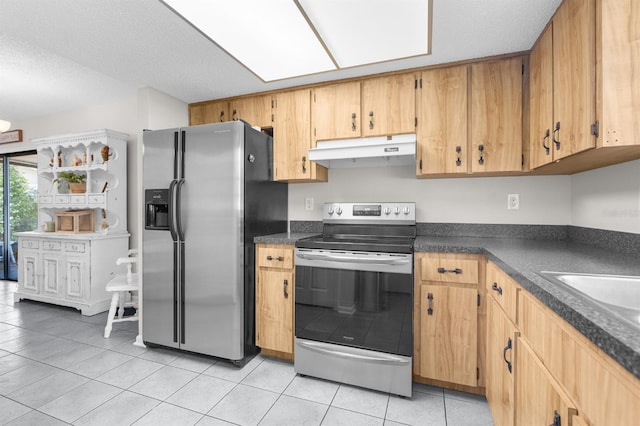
[0,0,560,121]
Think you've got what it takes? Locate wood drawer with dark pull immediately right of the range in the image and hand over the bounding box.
[420,254,478,284]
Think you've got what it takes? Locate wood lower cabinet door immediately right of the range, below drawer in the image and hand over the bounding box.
[420,284,478,386]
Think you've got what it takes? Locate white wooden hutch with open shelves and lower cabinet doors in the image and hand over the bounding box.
[14,129,129,315]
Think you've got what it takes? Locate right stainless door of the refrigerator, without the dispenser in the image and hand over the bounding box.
[180,122,244,360]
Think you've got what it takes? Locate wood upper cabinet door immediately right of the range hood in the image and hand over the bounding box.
[416,65,469,176]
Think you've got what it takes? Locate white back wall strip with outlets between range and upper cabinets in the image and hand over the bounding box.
[289,166,571,225]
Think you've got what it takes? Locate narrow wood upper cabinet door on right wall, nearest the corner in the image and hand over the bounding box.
[529,23,554,169]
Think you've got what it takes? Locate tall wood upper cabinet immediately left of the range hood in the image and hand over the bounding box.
[273,89,328,182]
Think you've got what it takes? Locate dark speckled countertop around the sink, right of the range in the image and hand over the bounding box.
[415,236,640,378]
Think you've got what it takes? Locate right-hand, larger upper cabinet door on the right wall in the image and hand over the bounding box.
[552,0,596,160]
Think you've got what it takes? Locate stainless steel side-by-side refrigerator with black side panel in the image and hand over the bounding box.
[142,121,287,364]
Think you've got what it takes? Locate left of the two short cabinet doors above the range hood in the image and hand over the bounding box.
[311,81,361,140]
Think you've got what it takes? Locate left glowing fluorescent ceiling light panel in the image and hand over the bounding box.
[164,0,336,81]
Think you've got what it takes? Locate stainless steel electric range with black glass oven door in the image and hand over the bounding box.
[294,202,416,397]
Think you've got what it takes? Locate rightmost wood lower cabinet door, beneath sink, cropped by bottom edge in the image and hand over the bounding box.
[515,338,577,426]
